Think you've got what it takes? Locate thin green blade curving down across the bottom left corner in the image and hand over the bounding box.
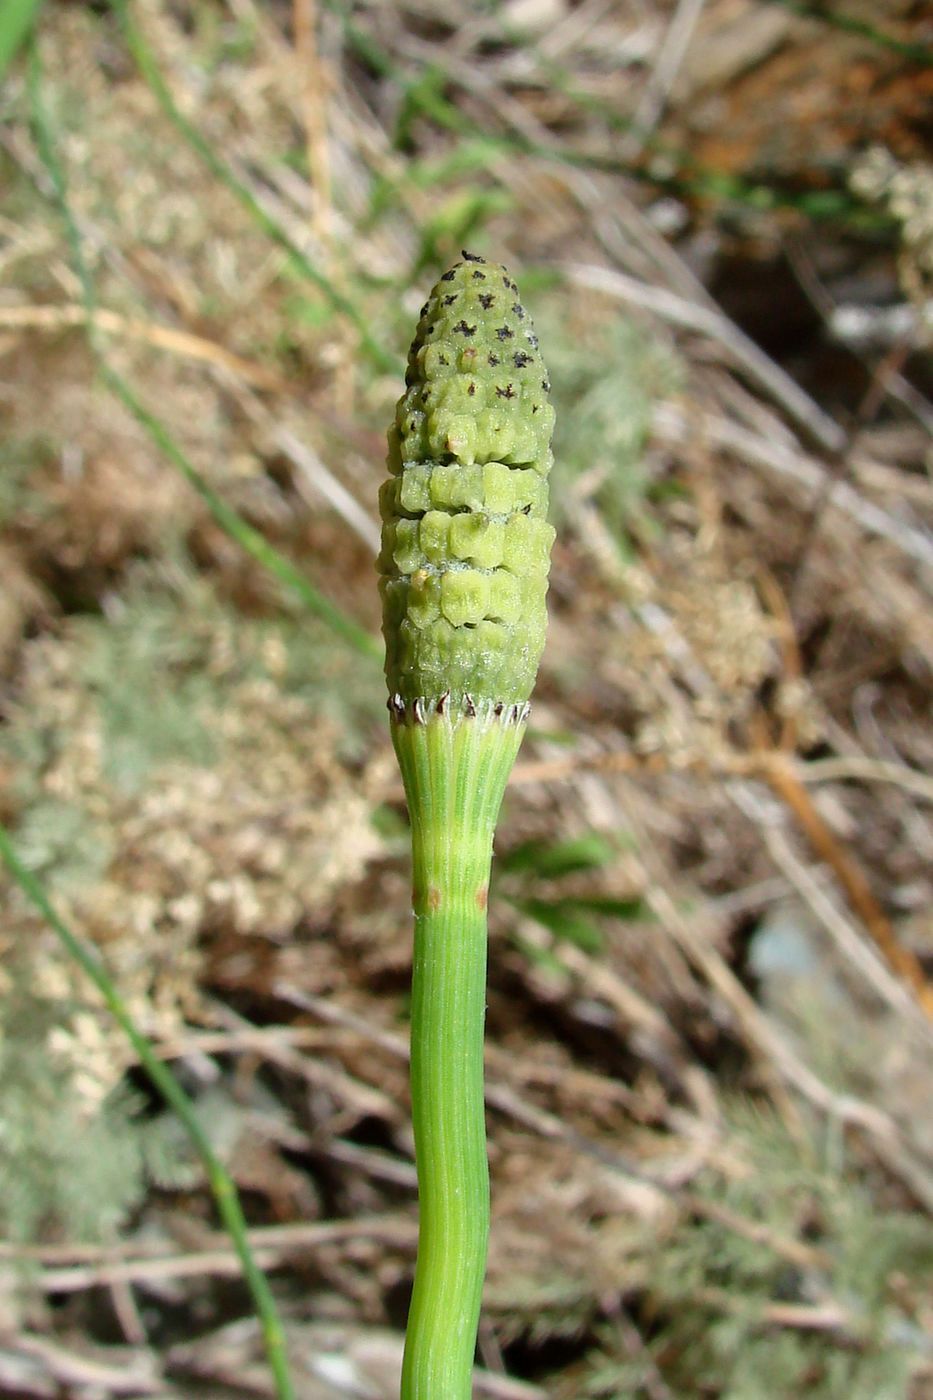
[0,826,294,1400]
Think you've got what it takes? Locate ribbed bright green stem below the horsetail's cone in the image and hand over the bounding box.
[392,701,524,1400]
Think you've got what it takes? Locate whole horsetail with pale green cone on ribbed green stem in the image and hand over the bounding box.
[378,252,553,1400]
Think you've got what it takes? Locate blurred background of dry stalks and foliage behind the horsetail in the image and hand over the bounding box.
[0,0,933,1400]
